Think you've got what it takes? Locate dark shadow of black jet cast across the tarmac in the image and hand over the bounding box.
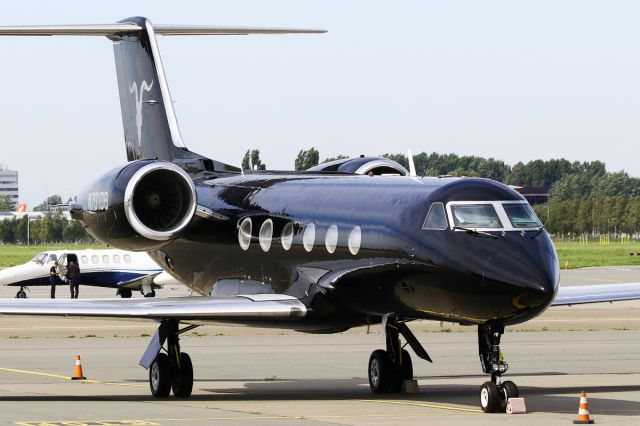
[0,378,640,416]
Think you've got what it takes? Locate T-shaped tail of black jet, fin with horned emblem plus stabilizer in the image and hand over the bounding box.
[0,17,324,171]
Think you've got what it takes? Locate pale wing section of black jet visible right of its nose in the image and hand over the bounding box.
[552,283,640,306]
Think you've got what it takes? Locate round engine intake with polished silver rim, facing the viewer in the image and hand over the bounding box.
[124,162,196,241]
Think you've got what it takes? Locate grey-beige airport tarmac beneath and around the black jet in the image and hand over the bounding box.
[0,267,640,425]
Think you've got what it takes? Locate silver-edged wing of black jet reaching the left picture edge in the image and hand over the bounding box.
[0,294,307,321]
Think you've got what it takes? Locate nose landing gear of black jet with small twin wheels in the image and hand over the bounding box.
[478,323,519,413]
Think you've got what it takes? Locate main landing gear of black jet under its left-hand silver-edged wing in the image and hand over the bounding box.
[140,320,197,398]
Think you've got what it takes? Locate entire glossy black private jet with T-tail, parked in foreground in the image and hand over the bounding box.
[0,17,640,412]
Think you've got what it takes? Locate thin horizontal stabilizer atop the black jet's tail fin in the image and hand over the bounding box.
[0,23,326,36]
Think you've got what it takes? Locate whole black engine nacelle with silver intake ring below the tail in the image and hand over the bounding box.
[72,160,197,251]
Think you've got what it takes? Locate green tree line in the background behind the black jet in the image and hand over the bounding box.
[0,147,640,243]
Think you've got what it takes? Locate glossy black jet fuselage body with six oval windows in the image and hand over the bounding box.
[102,168,558,331]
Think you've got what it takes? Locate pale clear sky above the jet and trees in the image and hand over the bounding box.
[0,0,640,207]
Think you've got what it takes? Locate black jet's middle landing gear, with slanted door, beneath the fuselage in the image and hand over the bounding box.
[369,320,432,393]
